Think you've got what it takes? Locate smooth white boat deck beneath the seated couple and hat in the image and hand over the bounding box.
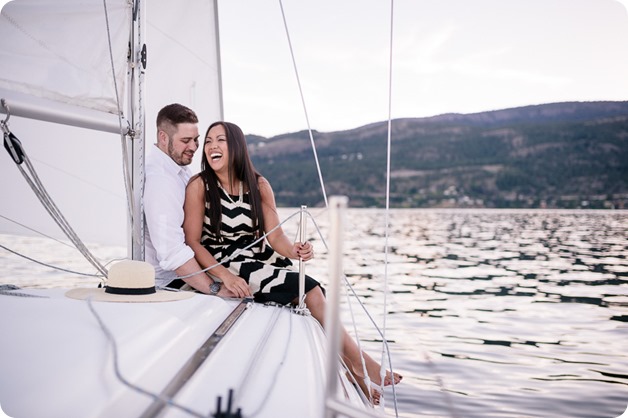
[0,289,372,418]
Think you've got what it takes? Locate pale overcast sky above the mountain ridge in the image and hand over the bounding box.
[218,0,628,137]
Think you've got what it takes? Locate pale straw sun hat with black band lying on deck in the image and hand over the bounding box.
[65,260,194,302]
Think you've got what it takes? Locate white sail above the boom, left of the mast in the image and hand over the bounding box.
[0,0,132,132]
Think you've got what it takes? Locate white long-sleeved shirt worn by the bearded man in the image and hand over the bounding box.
[144,145,194,286]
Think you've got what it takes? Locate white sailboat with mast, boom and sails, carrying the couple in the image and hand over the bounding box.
[0,0,390,418]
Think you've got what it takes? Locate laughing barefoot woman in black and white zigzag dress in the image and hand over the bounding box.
[183,122,401,404]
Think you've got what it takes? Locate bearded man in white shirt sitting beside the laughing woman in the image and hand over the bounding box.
[144,103,230,296]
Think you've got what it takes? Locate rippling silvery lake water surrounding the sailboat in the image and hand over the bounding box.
[0,209,628,418]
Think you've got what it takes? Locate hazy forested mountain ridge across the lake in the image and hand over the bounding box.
[247,102,628,208]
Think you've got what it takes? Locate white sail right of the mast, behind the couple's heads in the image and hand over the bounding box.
[145,0,223,166]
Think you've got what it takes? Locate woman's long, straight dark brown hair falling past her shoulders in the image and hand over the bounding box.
[199,121,264,239]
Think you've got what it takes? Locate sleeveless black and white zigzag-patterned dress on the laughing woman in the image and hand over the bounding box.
[201,188,319,305]
